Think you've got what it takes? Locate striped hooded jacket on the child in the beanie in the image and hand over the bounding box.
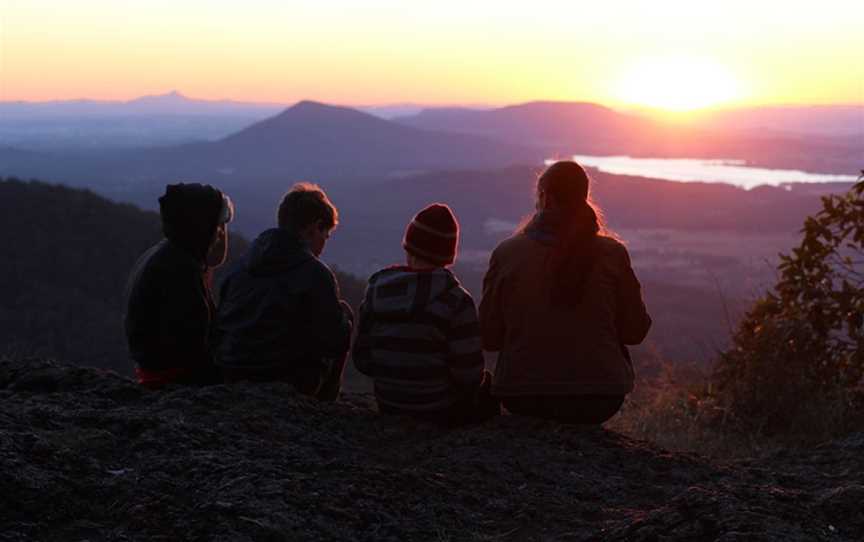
[353,267,484,412]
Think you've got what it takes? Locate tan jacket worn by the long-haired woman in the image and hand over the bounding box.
[480,234,651,396]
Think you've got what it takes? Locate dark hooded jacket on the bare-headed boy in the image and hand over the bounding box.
[214,228,351,376]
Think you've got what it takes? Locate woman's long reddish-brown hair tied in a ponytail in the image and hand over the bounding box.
[522,161,606,306]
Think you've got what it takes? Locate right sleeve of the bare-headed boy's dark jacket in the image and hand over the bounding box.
[309,264,353,358]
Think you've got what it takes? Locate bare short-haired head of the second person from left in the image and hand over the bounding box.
[276,183,339,256]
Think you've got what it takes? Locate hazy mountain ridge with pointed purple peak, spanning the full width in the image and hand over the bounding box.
[0,94,864,209]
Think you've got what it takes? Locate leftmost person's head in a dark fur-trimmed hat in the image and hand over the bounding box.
[159,183,234,266]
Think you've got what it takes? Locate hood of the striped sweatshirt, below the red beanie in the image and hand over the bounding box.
[366,266,460,320]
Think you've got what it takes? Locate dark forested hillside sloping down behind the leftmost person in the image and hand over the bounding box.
[0,179,245,371]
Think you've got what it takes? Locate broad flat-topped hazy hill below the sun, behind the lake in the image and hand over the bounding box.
[397,102,864,174]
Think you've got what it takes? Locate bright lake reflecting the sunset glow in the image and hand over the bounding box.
[573,155,857,190]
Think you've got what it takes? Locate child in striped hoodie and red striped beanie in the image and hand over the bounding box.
[353,203,500,425]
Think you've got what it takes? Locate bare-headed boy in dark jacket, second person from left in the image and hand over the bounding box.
[214,183,353,401]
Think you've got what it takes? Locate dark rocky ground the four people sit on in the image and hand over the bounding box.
[0,360,864,541]
